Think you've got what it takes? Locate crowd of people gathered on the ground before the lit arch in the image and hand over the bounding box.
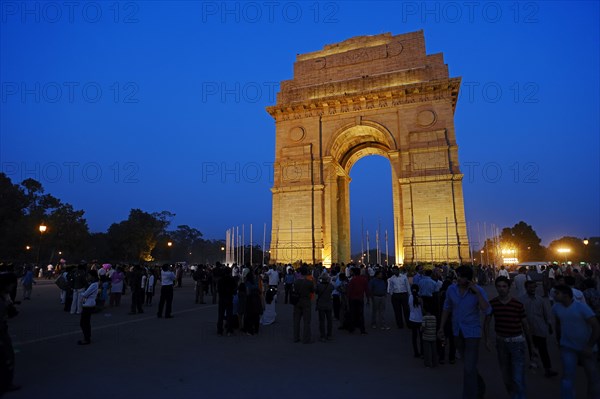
[0,261,600,398]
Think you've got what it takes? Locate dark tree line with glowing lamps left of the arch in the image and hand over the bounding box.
[0,173,233,264]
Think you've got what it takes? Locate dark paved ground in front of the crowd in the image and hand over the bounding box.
[6,279,585,399]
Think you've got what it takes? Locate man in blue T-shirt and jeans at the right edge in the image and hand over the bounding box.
[552,285,600,399]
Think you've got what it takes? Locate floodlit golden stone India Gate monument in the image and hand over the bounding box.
[267,31,470,265]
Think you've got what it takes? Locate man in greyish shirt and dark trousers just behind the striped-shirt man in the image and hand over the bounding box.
[520,281,558,377]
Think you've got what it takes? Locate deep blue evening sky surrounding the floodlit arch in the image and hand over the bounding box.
[0,1,600,253]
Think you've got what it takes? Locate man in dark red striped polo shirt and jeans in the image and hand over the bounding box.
[483,276,531,399]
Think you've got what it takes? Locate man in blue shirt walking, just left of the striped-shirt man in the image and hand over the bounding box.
[438,266,491,399]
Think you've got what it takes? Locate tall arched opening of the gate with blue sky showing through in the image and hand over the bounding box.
[349,153,395,265]
